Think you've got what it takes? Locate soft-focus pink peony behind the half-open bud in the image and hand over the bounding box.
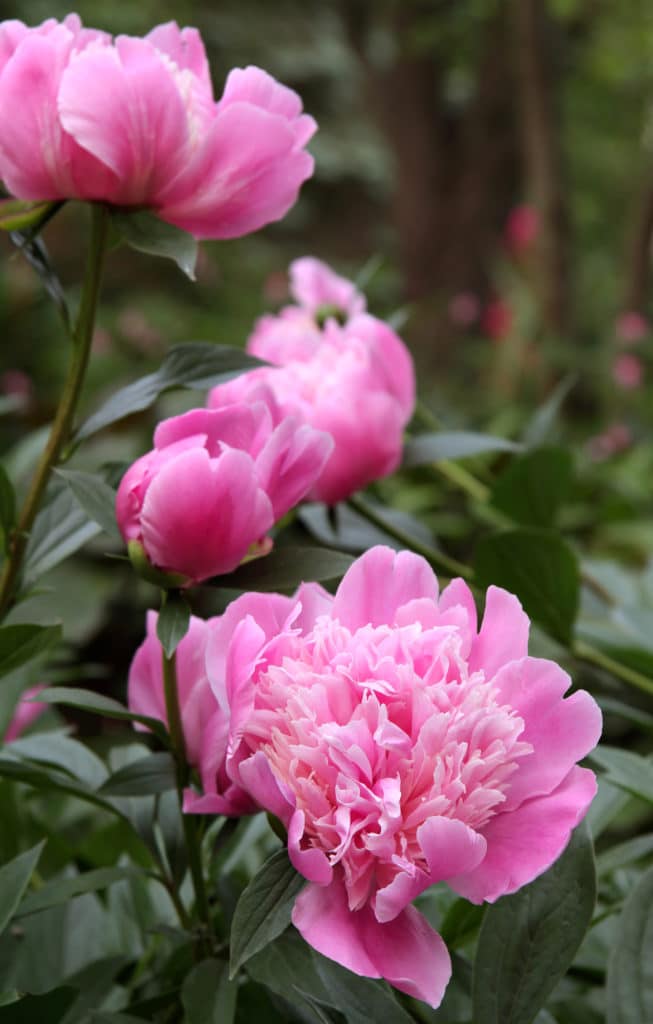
[209,259,415,505]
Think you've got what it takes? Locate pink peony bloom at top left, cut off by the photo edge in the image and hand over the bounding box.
[0,14,315,239]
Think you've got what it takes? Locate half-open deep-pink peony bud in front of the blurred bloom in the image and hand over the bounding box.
[116,401,333,583]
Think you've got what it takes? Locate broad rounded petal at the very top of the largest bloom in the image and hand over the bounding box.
[333,545,438,630]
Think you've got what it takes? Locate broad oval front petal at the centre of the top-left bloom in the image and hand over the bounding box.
[58,36,188,206]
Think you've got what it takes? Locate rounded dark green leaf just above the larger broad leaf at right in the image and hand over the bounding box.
[491,449,573,526]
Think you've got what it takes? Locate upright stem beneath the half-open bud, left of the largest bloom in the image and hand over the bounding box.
[163,652,211,959]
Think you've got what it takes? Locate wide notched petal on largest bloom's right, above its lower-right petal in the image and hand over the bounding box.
[495,657,602,813]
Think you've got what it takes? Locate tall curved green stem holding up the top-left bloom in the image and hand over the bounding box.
[0,204,108,618]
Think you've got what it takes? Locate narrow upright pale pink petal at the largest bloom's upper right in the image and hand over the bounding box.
[469,587,530,679]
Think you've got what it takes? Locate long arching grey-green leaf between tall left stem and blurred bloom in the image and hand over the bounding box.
[76,341,264,441]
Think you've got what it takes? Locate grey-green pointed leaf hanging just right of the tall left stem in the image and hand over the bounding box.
[24,480,100,587]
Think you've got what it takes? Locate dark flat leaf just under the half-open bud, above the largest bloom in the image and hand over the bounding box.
[215,547,354,593]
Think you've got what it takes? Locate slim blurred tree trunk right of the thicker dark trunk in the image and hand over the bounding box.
[513,0,571,334]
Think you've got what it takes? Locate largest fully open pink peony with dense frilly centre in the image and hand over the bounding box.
[207,547,601,1007]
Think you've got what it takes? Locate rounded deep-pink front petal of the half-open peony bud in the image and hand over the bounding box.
[140,449,273,582]
